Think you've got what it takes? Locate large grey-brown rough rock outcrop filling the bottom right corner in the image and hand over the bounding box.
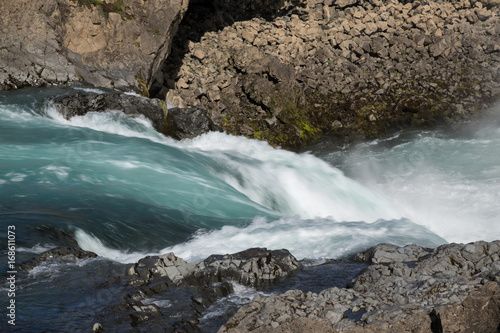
[219,241,500,333]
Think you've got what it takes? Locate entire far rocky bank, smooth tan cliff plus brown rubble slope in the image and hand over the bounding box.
[0,0,500,148]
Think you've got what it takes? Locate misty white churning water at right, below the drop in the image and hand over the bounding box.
[326,129,500,243]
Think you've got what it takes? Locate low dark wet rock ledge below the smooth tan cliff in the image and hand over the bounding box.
[48,93,166,133]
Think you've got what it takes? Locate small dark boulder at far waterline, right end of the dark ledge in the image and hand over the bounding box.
[163,108,218,140]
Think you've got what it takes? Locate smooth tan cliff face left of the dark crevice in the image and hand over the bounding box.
[0,0,188,94]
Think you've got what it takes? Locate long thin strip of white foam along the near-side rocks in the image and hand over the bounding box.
[75,217,444,263]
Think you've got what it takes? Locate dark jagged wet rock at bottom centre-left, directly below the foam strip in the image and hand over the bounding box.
[122,248,301,331]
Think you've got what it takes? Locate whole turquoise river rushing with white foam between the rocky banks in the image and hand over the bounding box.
[0,88,500,330]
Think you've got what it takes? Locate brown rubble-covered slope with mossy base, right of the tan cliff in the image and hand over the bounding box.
[160,0,500,147]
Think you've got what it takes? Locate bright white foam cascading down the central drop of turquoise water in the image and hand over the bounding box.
[182,133,402,222]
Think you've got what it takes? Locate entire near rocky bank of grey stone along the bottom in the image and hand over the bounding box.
[21,241,500,333]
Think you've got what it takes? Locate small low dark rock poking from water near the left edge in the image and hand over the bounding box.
[18,247,97,272]
